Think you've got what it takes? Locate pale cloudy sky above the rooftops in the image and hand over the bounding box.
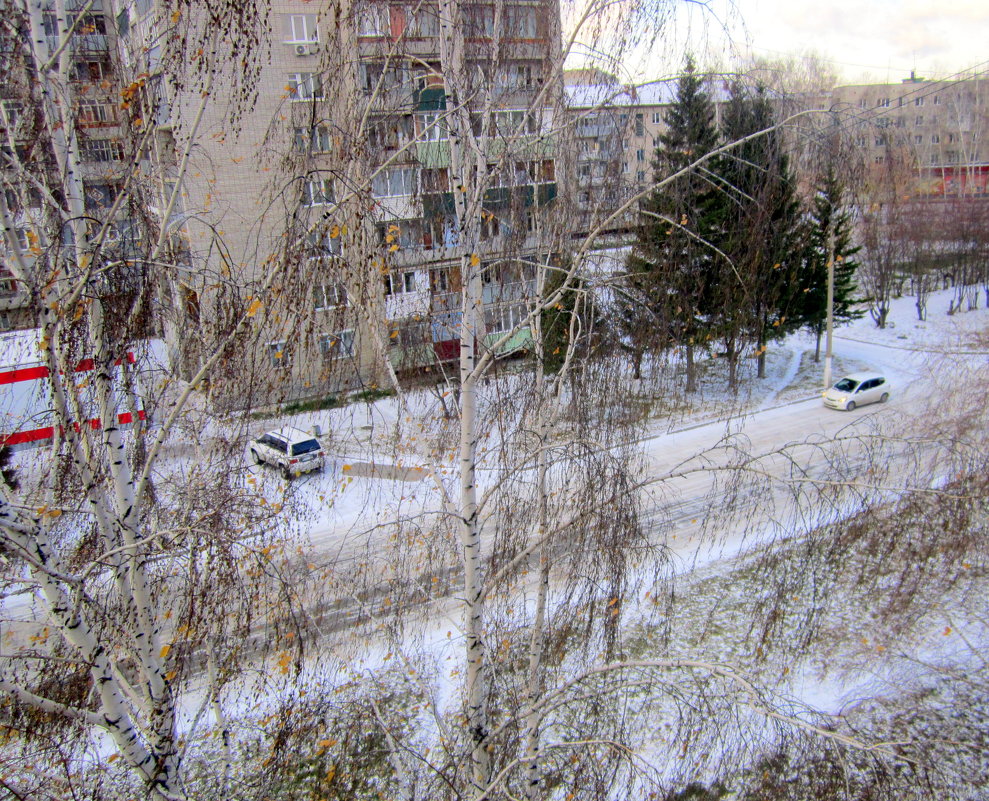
[604,0,989,83]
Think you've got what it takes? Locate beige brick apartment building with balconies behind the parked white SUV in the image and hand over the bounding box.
[109,0,559,398]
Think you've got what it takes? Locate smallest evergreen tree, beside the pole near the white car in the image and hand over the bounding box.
[799,165,863,362]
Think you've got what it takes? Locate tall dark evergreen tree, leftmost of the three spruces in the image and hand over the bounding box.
[622,57,724,392]
